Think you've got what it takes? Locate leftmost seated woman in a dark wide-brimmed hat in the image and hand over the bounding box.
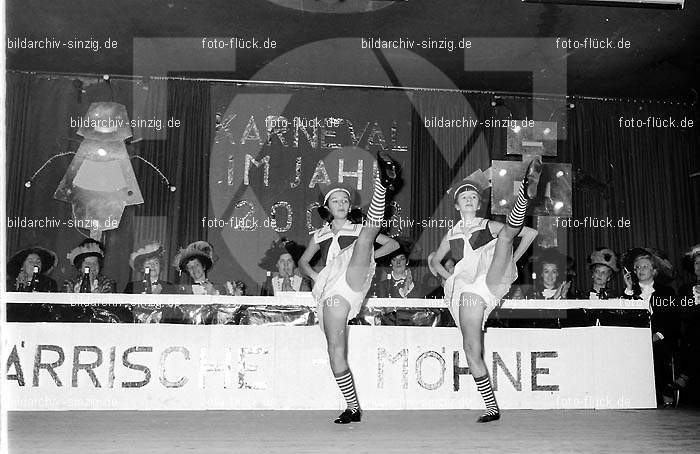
[7,246,58,292]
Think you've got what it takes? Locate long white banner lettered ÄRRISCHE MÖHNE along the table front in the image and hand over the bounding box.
[3,323,655,411]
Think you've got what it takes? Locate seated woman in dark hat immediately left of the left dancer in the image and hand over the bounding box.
[260,238,311,295]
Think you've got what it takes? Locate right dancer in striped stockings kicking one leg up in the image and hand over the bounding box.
[432,156,542,423]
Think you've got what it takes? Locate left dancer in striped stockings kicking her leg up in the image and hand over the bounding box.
[299,151,399,424]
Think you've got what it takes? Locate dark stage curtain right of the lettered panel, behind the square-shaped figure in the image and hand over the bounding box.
[411,92,700,289]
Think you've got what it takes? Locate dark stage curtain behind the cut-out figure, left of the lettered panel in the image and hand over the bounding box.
[6,72,212,290]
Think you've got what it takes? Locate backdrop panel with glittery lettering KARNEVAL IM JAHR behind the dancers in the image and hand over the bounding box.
[208,85,411,291]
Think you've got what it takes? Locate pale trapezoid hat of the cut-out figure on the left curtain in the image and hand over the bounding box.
[76,102,131,141]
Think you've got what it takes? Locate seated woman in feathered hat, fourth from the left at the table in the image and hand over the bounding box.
[174,241,226,295]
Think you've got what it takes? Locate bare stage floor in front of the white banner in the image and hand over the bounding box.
[8,410,700,454]
